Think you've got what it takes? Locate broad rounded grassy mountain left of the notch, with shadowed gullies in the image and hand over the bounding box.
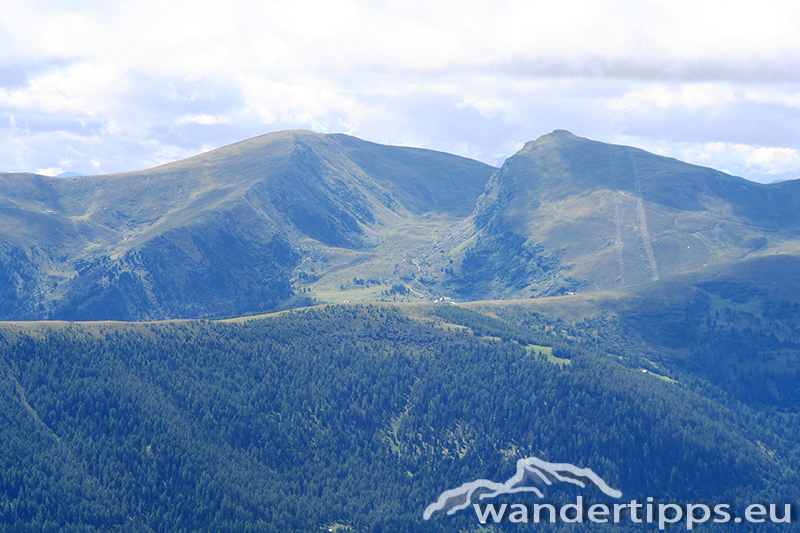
[0,132,494,319]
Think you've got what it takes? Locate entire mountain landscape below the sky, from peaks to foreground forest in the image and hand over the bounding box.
[0,130,800,533]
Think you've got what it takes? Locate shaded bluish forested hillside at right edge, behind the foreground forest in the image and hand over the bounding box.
[466,254,800,413]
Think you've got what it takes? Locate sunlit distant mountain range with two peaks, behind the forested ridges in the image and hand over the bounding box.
[0,130,800,320]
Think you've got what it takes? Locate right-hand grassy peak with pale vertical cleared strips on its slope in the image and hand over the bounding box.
[456,127,800,297]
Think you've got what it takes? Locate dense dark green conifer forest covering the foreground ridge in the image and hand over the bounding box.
[0,306,800,532]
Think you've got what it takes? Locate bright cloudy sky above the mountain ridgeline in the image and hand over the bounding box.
[0,0,800,183]
